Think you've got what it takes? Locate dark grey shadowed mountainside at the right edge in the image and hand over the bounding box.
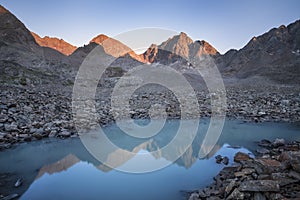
[216,20,300,84]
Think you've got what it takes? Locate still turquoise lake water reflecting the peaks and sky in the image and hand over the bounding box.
[0,120,300,200]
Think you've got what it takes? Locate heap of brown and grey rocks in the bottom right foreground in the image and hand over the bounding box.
[189,139,300,200]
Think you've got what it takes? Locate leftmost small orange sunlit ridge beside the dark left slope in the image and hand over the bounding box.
[31,32,77,56]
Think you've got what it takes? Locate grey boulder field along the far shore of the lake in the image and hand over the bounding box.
[0,86,300,150]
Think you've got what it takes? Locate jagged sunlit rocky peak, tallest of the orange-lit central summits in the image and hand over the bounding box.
[143,32,219,64]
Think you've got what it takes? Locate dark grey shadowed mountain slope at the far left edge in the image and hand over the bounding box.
[0,6,73,88]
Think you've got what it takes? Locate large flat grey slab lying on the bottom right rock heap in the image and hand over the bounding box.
[239,180,280,192]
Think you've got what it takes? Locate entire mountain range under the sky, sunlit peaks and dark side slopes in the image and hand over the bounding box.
[0,6,300,84]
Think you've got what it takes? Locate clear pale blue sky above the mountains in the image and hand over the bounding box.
[0,0,300,53]
